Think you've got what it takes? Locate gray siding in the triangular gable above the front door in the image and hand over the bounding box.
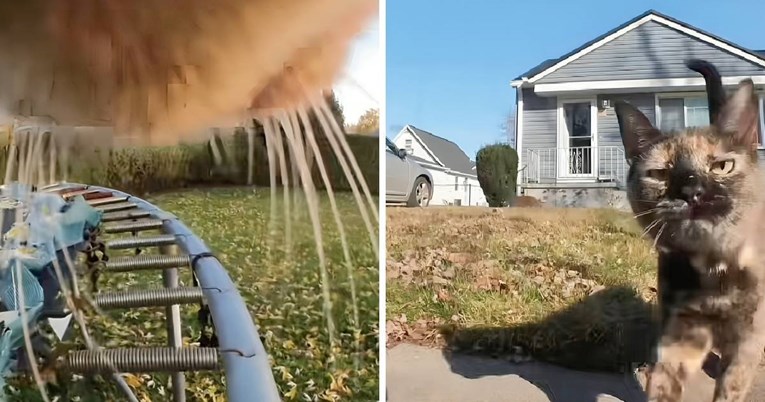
[536,21,765,84]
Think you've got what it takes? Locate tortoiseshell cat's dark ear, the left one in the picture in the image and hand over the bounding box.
[614,101,663,164]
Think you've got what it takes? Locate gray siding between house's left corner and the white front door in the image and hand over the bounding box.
[519,88,558,183]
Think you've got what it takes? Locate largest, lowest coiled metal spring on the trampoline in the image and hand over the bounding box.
[63,347,220,373]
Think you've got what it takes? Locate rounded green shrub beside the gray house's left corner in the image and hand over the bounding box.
[476,144,518,207]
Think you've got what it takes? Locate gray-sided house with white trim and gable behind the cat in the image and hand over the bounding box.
[512,10,765,206]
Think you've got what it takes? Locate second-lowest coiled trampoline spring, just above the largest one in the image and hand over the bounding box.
[94,287,204,309]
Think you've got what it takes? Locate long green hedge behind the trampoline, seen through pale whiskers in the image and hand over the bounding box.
[0,130,379,196]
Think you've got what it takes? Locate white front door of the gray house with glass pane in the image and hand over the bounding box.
[558,100,597,178]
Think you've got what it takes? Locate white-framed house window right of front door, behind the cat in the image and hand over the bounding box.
[658,96,709,131]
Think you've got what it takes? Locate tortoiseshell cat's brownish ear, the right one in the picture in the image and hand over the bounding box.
[716,79,760,150]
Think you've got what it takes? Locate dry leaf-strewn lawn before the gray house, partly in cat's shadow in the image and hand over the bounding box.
[386,207,656,369]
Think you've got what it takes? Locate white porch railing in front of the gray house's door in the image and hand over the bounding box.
[521,146,628,187]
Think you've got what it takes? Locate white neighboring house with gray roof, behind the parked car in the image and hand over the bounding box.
[392,124,488,206]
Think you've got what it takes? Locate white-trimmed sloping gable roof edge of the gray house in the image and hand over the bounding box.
[513,10,765,82]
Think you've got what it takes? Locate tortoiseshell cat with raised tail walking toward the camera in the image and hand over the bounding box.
[615,61,765,402]
